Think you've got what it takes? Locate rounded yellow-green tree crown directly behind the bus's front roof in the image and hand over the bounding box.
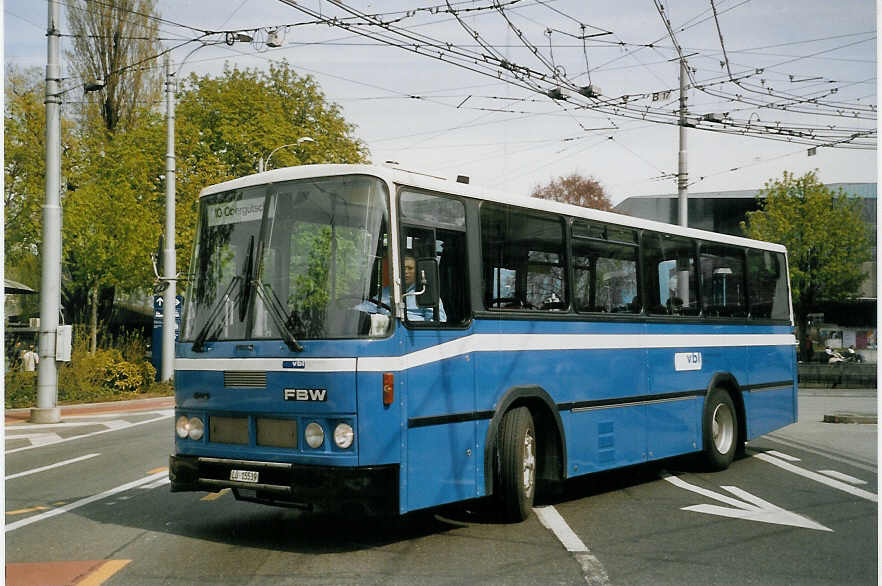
[175,61,368,267]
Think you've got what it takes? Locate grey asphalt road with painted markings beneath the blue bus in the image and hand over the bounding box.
[5,391,878,585]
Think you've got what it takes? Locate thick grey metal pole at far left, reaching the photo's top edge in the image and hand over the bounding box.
[30,0,61,423]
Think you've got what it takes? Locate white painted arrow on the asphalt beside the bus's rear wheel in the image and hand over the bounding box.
[662,473,833,532]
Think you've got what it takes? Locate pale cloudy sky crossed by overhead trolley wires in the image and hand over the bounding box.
[3,0,877,203]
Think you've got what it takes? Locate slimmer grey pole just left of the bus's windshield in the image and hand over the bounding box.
[160,53,178,381]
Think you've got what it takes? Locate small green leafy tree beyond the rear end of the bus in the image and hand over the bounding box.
[741,171,871,360]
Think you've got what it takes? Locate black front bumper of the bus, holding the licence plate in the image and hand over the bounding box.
[168,455,398,516]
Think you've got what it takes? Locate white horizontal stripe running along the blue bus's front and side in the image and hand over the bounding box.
[175,334,796,372]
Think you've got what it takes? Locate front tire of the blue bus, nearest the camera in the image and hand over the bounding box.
[497,407,536,523]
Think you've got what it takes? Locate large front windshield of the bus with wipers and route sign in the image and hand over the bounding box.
[182,175,389,348]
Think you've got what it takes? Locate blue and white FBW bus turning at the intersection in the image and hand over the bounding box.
[170,165,797,521]
